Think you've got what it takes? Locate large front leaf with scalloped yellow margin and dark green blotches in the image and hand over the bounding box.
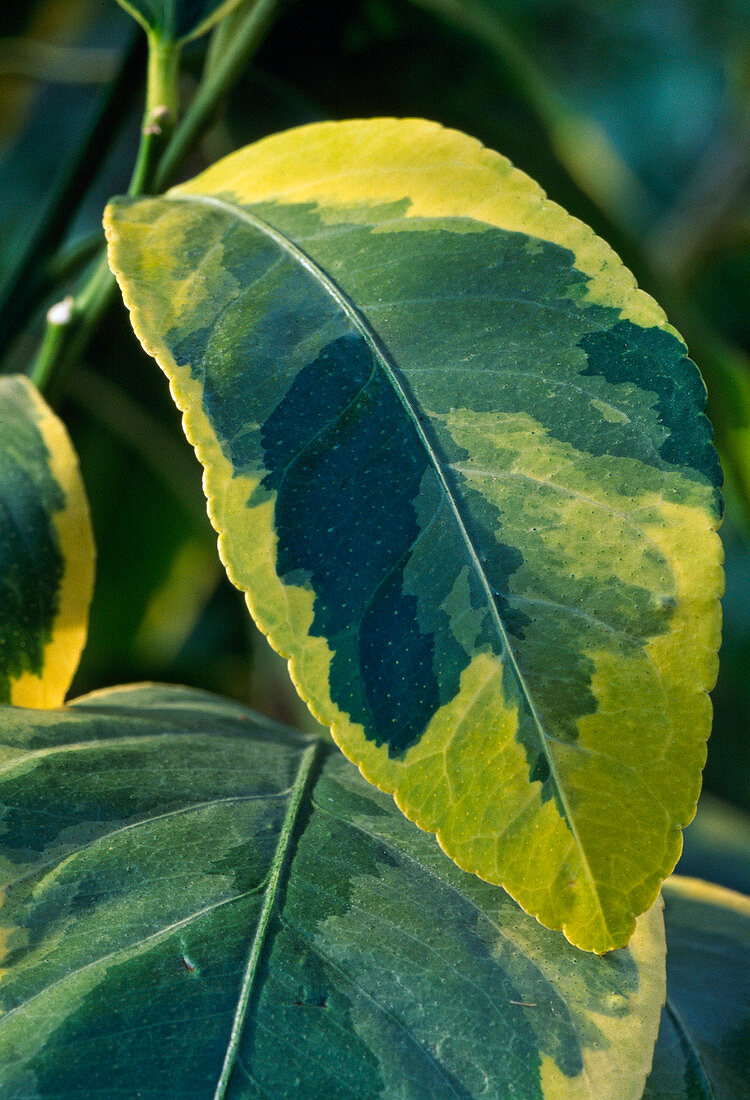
[106,119,721,952]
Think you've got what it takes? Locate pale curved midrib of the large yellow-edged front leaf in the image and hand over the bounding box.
[164,191,609,932]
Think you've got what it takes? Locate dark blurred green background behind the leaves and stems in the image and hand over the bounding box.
[0,0,750,831]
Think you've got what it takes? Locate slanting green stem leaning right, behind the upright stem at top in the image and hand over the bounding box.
[155,0,282,191]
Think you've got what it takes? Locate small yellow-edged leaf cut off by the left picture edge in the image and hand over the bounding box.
[0,375,93,707]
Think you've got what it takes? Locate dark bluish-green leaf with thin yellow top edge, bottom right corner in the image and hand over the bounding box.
[643,875,750,1100]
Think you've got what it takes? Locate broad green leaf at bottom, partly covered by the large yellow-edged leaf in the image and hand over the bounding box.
[0,686,664,1100]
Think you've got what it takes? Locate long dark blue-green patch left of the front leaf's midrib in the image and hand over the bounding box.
[262,333,461,755]
